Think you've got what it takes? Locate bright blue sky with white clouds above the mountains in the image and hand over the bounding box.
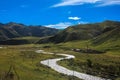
[0,0,120,29]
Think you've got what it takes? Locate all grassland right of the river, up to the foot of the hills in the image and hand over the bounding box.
[35,40,120,80]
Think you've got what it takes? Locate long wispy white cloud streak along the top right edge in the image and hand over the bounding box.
[51,0,120,7]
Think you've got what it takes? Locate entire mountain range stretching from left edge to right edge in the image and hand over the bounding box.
[0,20,120,47]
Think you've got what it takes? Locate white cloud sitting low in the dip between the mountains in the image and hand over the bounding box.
[45,22,73,29]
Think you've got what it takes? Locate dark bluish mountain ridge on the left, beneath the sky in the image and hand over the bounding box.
[0,22,59,41]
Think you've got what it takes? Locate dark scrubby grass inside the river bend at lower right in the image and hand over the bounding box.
[59,52,120,78]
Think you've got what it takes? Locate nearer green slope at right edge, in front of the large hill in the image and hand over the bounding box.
[91,26,120,50]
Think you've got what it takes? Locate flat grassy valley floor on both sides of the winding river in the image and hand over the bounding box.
[0,44,120,80]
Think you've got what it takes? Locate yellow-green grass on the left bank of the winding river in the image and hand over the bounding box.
[0,44,79,80]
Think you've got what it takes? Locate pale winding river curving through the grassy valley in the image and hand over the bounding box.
[36,50,110,80]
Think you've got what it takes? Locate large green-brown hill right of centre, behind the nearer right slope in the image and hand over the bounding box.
[38,20,120,43]
